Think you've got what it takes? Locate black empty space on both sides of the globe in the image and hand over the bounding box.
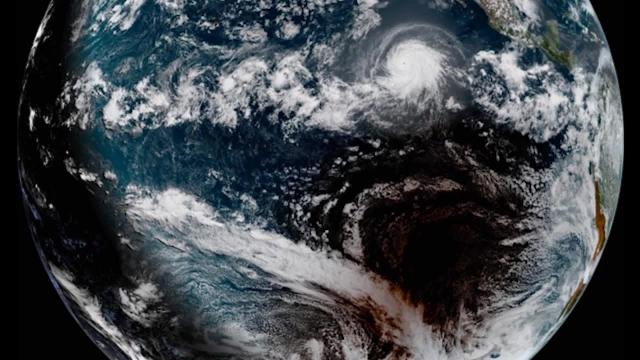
[15,0,636,360]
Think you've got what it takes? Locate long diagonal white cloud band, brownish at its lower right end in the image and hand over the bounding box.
[127,189,456,358]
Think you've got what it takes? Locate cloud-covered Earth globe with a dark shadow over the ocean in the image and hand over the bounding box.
[18,0,623,359]
